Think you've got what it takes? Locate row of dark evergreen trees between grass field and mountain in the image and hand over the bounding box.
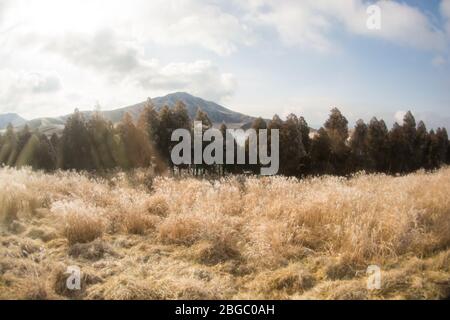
[0,99,450,177]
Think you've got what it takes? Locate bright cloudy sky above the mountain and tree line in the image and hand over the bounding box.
[0,0,450,128]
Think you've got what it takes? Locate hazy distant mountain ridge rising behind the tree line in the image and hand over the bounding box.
[6,92,255,135]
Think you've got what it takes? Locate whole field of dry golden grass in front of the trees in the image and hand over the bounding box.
[0,168,450,299]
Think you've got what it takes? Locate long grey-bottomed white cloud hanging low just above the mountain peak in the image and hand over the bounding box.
[46,31,236,101]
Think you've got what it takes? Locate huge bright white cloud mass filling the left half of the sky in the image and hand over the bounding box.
[0,0,239,117]
